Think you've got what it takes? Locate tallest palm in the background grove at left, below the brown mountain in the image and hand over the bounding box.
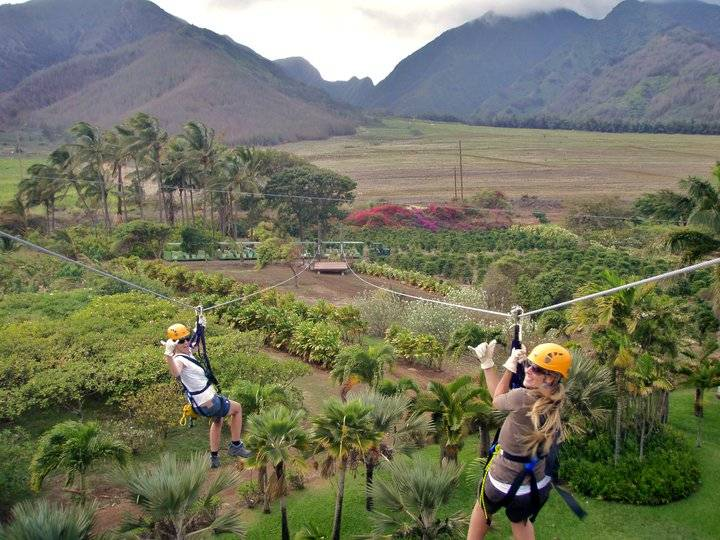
[115,112,168,221]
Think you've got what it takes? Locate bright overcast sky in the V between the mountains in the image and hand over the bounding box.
[8,0,720,83]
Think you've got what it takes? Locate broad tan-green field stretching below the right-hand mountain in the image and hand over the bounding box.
[281,119,720,202]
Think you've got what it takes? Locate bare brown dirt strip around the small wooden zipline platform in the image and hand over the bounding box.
[182,261,433,306]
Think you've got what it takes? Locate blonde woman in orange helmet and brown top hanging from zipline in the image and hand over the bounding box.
[467,340,572,540]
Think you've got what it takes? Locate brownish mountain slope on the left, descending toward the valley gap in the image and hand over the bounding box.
[0,0,359,143]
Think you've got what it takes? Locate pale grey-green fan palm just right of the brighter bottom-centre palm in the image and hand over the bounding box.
[358,391,432,510]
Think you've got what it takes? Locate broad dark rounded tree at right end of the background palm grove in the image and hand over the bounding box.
[263,166,357,240]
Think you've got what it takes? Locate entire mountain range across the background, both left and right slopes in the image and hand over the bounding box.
[0,0,720,143]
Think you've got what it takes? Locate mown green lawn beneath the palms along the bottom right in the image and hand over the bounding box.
[245,390,720,540]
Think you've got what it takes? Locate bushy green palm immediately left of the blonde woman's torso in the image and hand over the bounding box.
[415,375,483,464]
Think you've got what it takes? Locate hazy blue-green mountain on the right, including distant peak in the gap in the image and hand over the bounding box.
[278,0,720,129]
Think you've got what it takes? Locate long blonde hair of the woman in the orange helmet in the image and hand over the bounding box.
[522,383,565,456]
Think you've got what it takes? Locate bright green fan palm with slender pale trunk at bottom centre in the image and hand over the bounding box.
[313,399,382,540]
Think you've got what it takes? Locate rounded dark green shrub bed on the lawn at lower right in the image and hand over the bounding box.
[560,428,700,505]
